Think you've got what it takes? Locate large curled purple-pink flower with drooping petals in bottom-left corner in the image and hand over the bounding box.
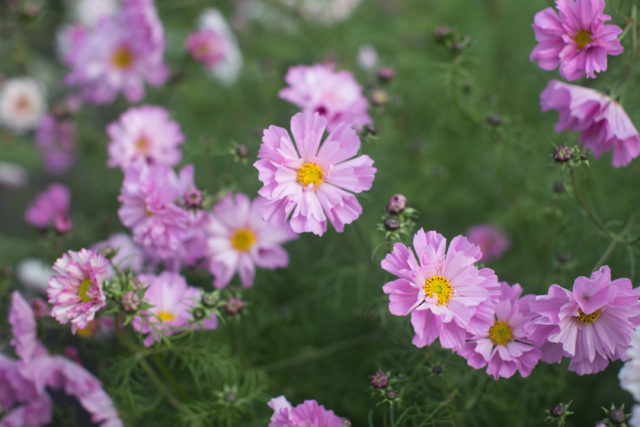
[0,292,122,427]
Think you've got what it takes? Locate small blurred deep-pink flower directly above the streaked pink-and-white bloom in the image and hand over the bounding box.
[25,184,71,233]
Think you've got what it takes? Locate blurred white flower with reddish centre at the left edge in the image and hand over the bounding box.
[0,77,46,133]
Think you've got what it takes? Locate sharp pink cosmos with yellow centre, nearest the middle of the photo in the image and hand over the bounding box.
[254,112,376,235]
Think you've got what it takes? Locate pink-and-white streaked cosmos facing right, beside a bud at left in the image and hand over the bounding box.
[47,249,109,334]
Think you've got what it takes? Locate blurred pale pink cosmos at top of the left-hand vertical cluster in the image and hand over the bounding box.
[107,105,184,169]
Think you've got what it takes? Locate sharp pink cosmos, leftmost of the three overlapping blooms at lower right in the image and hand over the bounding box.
[381,229,500,350]
